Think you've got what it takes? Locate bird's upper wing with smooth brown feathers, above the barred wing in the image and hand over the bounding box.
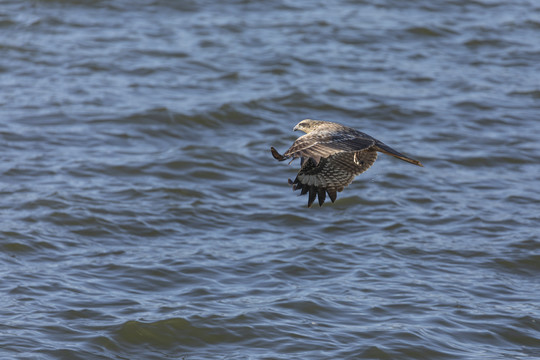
[283,131,375,164]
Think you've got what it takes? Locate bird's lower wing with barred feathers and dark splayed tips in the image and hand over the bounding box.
[289,148,377,207]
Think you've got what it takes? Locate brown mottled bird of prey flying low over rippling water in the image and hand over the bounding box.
[270,119,423,207]
